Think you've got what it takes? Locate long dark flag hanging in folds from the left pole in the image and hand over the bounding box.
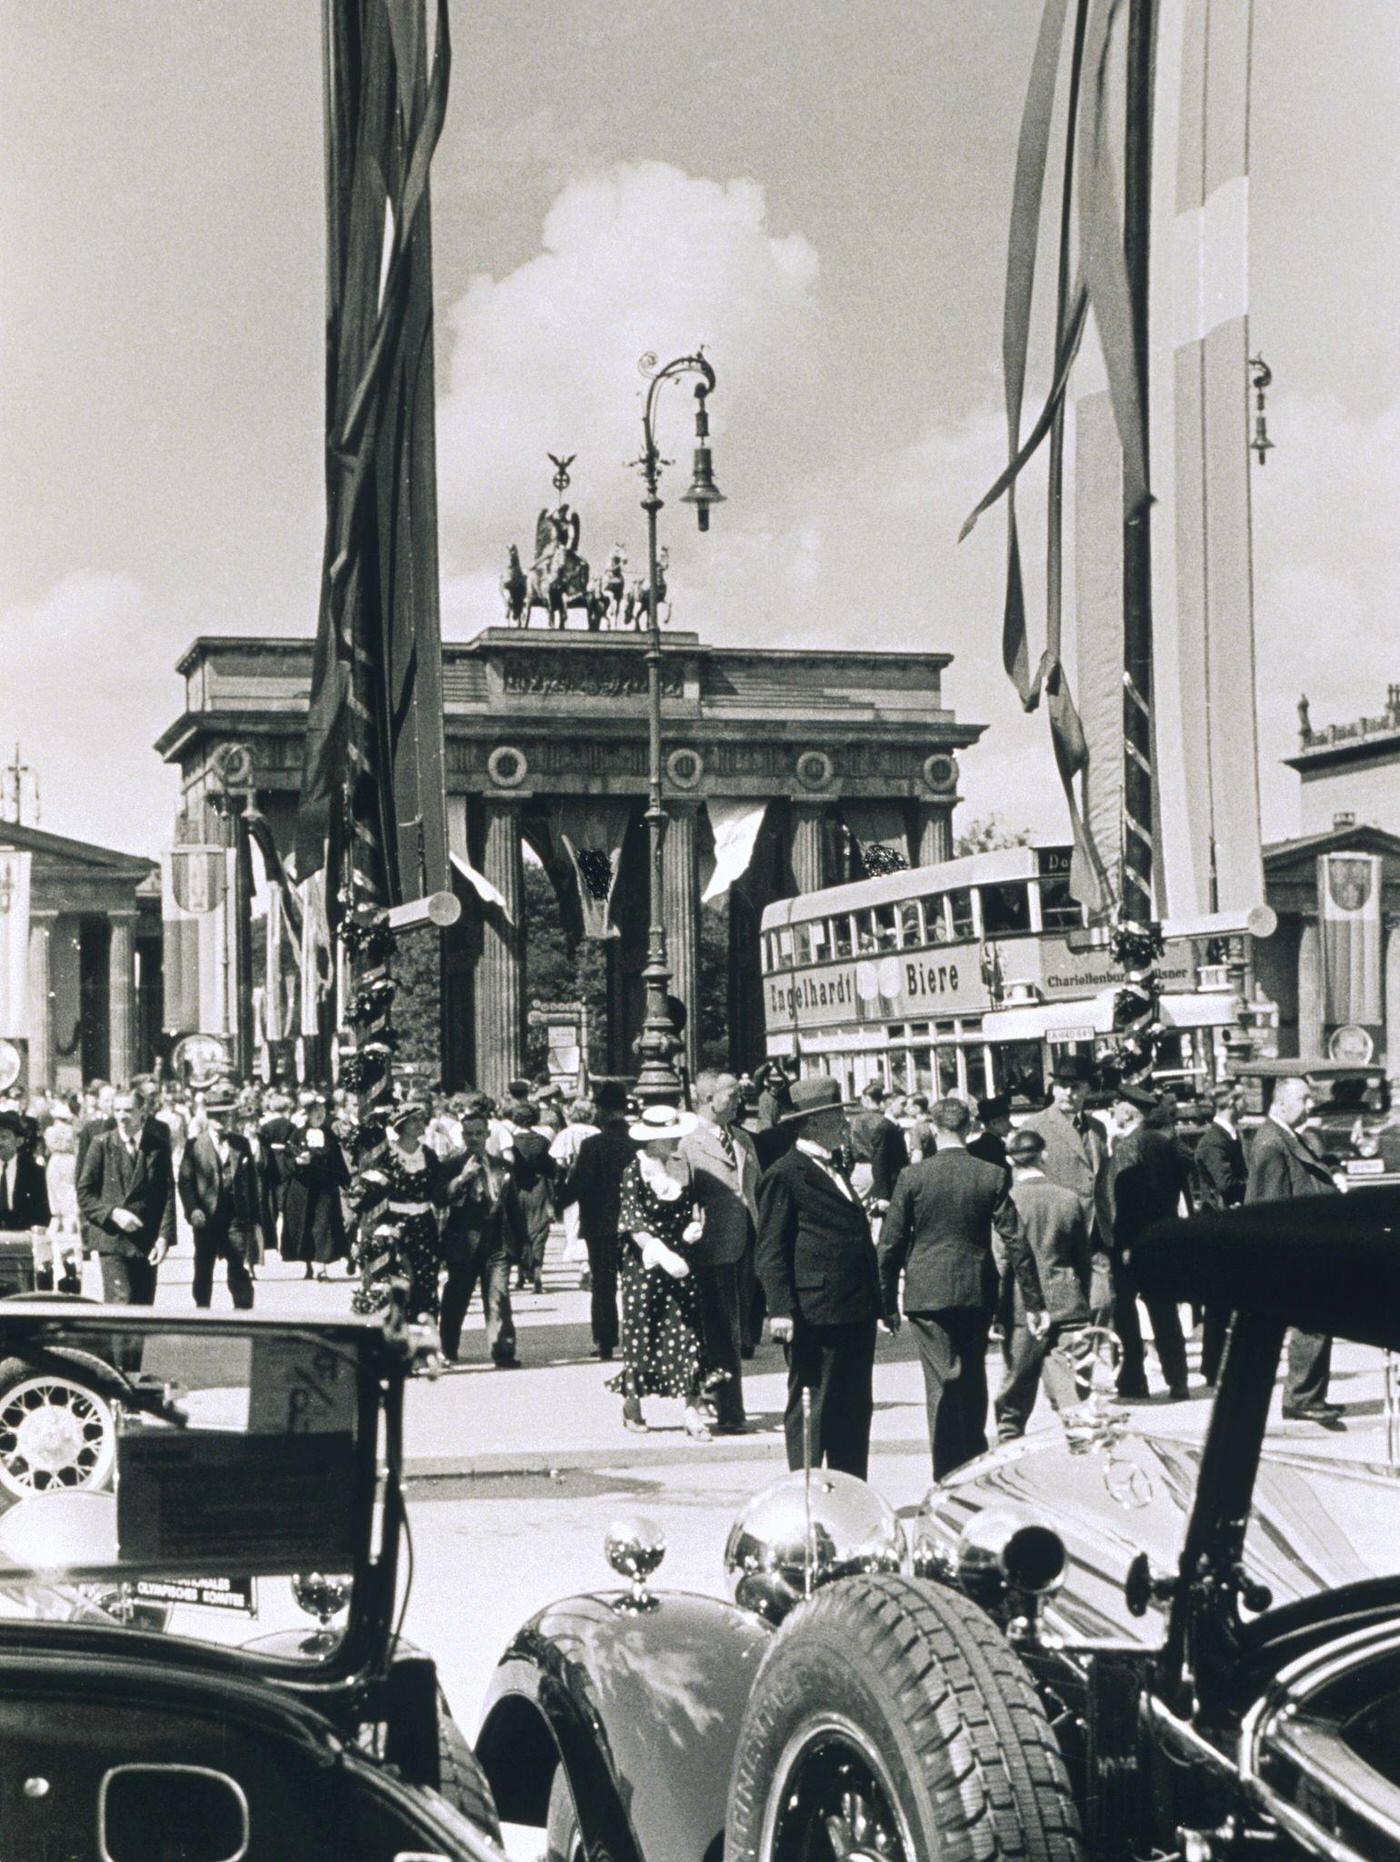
[296,0,451,914]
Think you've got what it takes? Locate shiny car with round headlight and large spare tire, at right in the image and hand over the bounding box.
[477,1188,1400,1862]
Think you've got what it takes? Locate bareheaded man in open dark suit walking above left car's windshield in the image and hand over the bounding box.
[78,1087,175,1305]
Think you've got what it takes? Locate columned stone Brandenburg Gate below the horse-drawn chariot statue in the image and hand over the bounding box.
[156,627,983,1091]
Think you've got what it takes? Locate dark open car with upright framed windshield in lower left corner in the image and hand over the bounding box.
[0,1300,501,1862]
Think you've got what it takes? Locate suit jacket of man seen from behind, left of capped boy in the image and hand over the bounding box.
[879,1145,1044,1316]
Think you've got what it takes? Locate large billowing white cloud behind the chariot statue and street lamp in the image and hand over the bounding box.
[438,162,823,575]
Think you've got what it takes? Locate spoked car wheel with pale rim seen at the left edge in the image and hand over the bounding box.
[0,1359,117,1501]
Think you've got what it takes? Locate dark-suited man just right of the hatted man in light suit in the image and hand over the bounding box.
[1110,1080,1190,1400]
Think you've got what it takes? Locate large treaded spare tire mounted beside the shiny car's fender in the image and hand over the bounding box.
[724,1575,1084,1862]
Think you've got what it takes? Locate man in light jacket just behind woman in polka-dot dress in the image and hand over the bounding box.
[680,1073,760,1436]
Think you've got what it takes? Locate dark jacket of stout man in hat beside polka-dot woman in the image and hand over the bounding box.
[754,1145,881,1326]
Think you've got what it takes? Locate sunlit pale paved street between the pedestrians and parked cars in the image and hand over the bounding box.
[148,1240,1385,1856]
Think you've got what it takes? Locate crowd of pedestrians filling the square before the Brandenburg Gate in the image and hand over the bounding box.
[0,1056,1342,1478]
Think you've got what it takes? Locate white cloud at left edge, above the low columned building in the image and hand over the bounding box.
[0,570,177,855]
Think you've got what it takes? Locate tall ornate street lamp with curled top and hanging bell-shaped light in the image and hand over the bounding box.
[637,350,724,1104]
